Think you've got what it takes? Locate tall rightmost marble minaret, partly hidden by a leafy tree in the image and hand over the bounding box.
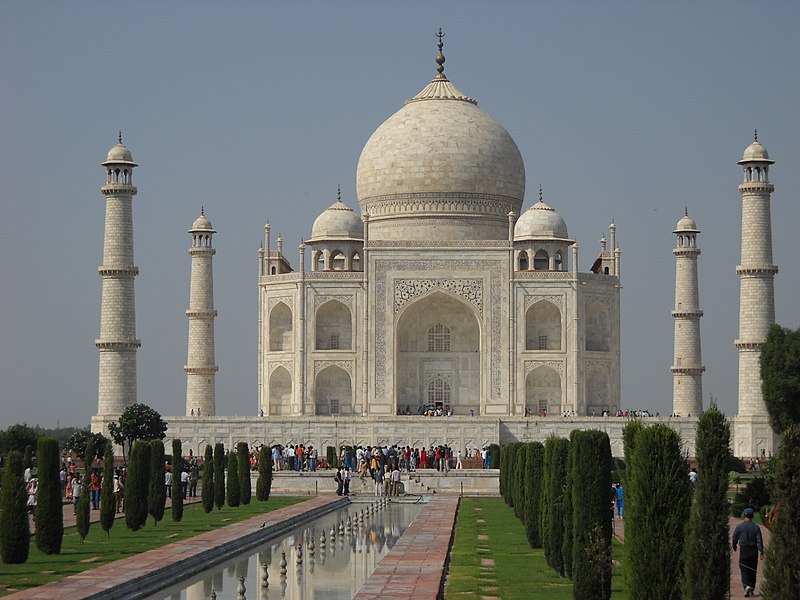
[735,131,778,417]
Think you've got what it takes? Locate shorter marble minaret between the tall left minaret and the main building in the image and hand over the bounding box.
[183,209,219,417]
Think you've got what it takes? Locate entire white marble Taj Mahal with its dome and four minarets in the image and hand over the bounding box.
[92,31,777,456]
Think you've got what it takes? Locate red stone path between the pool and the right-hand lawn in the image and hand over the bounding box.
[354,495,459,600]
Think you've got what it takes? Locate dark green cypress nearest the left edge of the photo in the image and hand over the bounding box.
[0,450,31,565]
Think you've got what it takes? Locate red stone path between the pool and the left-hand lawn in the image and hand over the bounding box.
[6,495,347,600]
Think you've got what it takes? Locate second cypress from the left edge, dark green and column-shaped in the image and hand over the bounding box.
[36,437,64,554]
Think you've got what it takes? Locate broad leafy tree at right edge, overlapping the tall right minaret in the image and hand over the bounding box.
[759,325,800,435]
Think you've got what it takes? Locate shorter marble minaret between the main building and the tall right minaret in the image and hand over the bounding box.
[670,210,706,417]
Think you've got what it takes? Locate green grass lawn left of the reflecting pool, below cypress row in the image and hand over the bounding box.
[0,496,306,596]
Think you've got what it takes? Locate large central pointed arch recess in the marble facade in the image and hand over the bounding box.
[394,291,481,415]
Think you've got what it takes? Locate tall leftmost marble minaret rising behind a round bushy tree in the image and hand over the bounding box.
[95,133,141,416]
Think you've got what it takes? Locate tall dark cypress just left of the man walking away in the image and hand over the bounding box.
[683,404,731,600]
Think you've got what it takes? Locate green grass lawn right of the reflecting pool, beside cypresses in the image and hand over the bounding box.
[445,498,624,600]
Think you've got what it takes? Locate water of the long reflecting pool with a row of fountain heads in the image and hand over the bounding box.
[147,503,424,600]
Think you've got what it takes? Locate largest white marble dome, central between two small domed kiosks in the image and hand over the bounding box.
[356,67,525,240]
